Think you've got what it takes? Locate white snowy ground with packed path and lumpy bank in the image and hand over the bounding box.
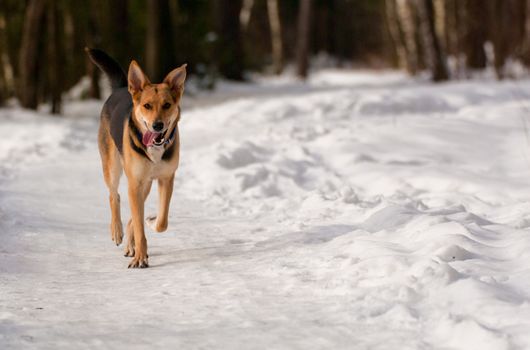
[0,71,530,350]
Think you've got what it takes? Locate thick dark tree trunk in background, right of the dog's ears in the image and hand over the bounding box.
[215,0,244,80]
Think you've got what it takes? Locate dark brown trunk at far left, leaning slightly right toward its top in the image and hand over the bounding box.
[17,0,46,109]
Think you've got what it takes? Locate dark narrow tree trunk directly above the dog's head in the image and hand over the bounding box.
[145,0,162,81]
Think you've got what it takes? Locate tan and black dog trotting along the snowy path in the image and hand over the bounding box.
[86,48,186,268]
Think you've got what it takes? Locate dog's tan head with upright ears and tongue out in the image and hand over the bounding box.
[128,61,186,146]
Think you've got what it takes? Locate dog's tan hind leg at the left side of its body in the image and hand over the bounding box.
[99,130,123,245]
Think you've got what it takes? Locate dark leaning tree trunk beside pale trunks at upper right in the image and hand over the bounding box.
[418,0,449,81]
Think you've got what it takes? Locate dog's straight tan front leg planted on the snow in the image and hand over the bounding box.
[129,179,151,268]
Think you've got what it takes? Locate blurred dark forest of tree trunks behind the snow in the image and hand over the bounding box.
[0,0,530,113]
